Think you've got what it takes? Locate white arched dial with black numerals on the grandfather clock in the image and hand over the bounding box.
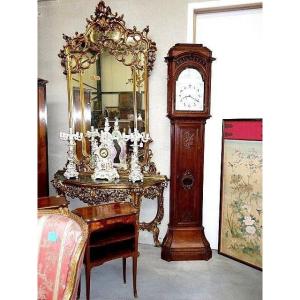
[175,68,204,111]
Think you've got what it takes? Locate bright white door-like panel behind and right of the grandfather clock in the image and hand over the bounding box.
[195,1,263,248]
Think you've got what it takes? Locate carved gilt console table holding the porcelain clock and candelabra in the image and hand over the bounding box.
[51,170,168,247]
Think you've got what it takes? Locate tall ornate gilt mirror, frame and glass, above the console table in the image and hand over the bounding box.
[59,1,157,173]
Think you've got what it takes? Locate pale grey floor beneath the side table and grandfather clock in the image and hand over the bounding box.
[80,244,262,300]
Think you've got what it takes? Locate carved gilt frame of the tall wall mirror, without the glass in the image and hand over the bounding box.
[58,1,157,174]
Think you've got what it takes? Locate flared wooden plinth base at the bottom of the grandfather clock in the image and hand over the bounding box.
[161,227,212,261]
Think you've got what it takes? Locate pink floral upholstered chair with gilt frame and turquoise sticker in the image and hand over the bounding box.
[38,208,88,300]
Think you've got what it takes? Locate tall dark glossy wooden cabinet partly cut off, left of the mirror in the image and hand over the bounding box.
[37,79,49,197]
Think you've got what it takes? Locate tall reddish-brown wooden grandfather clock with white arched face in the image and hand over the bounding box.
[161,44,214,261]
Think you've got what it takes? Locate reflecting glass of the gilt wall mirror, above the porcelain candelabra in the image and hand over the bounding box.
[72,51,146,133]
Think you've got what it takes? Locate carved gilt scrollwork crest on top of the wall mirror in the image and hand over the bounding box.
[58,1,157,77]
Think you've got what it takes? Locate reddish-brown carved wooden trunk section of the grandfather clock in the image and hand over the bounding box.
[172,121,204,226]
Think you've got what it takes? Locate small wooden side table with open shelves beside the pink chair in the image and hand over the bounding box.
[73,202,139,300]
